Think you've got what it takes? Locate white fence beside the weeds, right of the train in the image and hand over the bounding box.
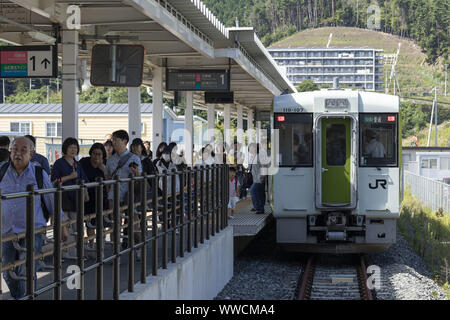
[404,171,450,213]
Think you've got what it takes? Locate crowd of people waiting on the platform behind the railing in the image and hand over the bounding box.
[0,130,265,298]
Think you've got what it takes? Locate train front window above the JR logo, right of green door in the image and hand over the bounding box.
[359,113,398,167]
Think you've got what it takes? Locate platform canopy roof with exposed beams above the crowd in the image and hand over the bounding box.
[0,0,296,110]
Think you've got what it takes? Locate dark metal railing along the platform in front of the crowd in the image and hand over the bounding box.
[0,165,229,300]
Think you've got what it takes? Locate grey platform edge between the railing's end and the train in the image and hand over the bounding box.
[228,197,272,237]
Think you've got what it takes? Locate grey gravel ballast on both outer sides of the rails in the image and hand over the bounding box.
[215,223,446,300]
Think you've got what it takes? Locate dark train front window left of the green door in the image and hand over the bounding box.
[274,113,313,167]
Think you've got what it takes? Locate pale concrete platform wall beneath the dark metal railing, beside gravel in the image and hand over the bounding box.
[120,227,233,300]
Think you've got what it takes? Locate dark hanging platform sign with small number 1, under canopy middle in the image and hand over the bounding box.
[166,69,230,91]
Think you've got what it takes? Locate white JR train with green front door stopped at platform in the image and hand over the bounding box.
[270,89,401,253]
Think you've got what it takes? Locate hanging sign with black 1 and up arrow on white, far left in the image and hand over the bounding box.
[0,46,58,78]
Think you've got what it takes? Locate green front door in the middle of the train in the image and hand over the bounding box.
[321,118,351,207]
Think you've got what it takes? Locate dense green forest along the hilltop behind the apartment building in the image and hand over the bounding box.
[203,0,450,63]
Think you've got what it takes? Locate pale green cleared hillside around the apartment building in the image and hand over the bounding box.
[270,27,450,146]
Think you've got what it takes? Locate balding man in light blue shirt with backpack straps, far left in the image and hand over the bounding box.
[0,137,68,299]
